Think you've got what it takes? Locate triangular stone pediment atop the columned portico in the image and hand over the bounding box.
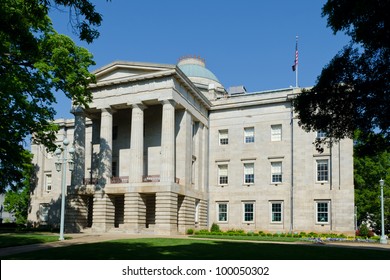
[93,61,175,83]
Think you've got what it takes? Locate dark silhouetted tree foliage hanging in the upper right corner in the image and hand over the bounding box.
[295,0,390,153]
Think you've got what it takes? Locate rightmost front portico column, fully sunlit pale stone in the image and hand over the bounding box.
[160,100,175,183]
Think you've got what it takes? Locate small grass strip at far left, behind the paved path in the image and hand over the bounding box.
[0,232,63,248]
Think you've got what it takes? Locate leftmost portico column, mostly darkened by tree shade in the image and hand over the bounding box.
[72,107,85,188]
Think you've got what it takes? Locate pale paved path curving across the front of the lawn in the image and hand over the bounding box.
[0,233,390,257]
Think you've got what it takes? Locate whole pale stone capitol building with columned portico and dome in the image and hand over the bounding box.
[29,57,354,235]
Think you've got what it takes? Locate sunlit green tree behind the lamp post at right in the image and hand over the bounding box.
[354,148,390,234]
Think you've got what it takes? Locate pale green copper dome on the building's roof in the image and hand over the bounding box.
[177,57,219,83]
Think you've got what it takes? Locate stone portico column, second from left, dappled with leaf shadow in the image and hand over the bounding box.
[99,109,114,186]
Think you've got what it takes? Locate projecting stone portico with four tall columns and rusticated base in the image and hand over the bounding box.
[68,61,209,234]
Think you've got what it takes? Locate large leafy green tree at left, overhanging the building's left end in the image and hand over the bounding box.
[0,0,106,192]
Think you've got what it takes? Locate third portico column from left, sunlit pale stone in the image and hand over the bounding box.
[129,104,146,183]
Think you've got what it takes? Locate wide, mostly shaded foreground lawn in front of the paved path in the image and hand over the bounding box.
[3,238,390,260]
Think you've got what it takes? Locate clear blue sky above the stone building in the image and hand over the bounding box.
[51,0,348,118]
